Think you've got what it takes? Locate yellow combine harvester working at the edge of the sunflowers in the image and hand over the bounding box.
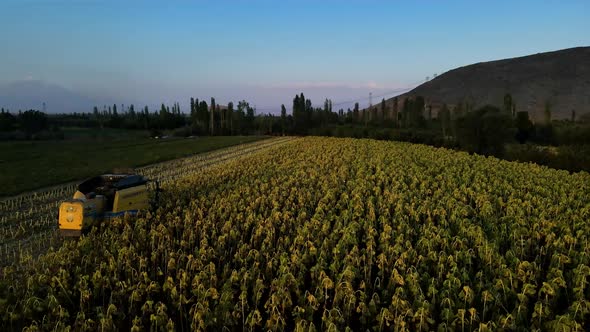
[59,174,159,236]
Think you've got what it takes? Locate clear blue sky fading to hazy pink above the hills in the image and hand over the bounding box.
[0,0,590,113]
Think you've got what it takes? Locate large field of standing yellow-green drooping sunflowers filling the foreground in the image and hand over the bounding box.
[0,137,590,331]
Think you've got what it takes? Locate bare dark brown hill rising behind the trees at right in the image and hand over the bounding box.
[388,47,590,121]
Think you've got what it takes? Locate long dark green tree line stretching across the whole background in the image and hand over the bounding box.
[0,93,590,170]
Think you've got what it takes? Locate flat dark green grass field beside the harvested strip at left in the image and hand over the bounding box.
[0,136,264,197]
